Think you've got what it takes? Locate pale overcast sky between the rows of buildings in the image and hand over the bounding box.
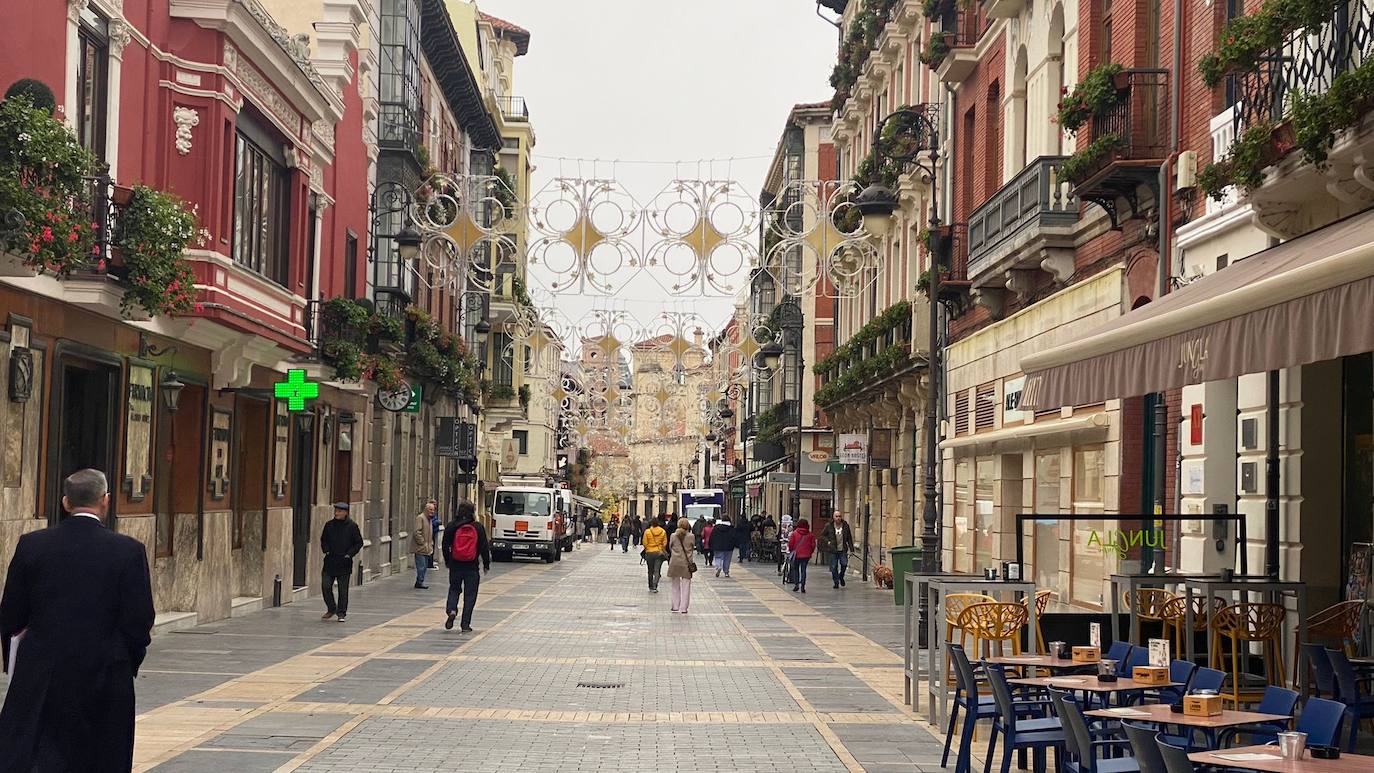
[478,0,837,347]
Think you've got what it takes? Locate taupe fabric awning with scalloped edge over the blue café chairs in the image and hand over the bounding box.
[1020,210,1374,411]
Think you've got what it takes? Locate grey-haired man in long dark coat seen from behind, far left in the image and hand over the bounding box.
[0,470,154,773]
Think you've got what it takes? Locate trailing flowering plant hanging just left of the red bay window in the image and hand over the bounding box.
[114,185,199,317]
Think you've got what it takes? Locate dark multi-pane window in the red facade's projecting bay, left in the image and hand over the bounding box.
[231,114,291,286]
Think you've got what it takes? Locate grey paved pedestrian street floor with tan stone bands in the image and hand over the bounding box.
[104,549,967,773]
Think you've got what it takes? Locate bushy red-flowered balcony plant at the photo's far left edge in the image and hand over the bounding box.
[0,89,104,276]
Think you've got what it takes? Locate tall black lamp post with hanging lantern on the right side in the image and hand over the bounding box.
[855,107,940,573]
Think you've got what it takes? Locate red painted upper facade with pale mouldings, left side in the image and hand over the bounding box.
[0,0,368,353]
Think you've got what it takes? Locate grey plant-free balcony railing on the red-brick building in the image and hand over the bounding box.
[969,155,1079,279]
